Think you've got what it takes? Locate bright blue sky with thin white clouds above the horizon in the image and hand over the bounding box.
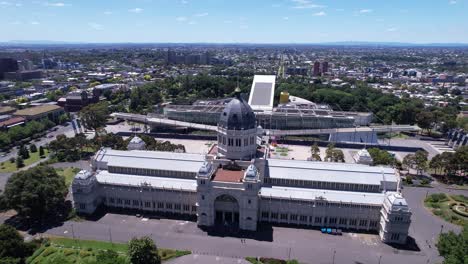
[0,0,468,43]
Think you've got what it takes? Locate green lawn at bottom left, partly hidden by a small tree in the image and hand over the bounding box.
[27,237,191,264]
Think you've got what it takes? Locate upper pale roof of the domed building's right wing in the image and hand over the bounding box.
[268,159,397,185]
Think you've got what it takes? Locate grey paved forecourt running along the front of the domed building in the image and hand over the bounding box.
[0,186,468,264]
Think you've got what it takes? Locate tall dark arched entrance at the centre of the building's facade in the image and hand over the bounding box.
[214,194,239,227]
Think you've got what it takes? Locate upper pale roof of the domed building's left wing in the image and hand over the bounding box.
[95,149,205,173]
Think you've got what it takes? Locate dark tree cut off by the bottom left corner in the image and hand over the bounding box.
[0,224,35,263]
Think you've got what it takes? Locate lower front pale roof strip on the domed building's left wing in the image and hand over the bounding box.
[96,171,197,192]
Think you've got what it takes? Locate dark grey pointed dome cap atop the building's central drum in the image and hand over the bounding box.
[218,94,255,130]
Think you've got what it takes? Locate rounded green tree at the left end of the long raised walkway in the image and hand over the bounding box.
[79,102,109,135]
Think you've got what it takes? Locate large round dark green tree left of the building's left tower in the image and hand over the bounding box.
[4,166,68,224]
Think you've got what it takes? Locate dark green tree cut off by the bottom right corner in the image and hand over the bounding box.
[436,225,468,264]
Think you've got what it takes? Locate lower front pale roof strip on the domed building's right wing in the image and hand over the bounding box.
[259,186,385,205]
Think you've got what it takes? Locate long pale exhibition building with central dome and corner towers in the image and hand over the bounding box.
[72,94,411,244]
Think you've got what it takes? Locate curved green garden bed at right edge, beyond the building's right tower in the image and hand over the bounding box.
[424,193,468,226]
